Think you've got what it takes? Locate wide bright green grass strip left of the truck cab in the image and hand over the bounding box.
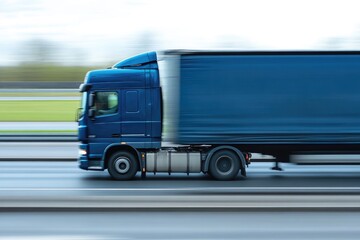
[0,100,80,122]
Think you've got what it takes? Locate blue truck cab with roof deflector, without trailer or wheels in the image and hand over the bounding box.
[78,52,161,174]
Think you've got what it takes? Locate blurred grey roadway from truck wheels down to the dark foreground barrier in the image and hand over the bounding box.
[0,161,360,204]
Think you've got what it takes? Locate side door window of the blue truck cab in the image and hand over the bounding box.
[95,92,119,116]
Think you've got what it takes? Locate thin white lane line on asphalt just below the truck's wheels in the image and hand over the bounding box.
[0,187,360,191]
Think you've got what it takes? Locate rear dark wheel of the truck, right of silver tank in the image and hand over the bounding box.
[209,150,240,181]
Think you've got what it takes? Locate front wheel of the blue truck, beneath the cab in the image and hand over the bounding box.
[108,151,139,180]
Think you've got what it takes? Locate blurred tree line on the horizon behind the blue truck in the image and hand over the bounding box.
[0,28,360,82]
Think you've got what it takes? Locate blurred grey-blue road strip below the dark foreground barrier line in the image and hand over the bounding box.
[0,211,360,240]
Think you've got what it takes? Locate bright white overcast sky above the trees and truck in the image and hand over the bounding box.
[0,0,360,65]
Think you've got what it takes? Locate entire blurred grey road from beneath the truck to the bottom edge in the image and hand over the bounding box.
[0,161,360,240]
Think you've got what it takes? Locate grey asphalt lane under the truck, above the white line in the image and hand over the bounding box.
[0,161,360,190]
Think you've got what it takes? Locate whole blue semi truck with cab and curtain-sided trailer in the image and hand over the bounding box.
[78,50,360,180]
